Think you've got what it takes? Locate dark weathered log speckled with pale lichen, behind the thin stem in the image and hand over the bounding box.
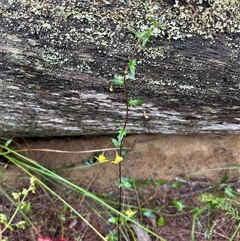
[0,0,240,136]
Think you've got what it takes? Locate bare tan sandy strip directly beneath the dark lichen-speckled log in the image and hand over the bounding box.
[6,135,240,191]
